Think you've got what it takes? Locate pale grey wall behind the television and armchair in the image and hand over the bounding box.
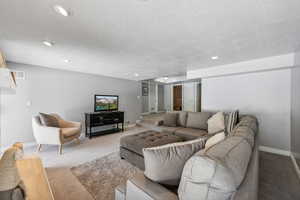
[0,63,141,146]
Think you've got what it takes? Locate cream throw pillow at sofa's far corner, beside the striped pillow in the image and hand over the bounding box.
[207,112,225,134]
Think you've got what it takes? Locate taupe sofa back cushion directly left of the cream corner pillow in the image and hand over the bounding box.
[186,112,212,130]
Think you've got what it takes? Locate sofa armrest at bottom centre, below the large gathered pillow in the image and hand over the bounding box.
[126,173,178,200]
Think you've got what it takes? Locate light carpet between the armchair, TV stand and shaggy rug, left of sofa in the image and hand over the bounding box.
[24,127,145,200]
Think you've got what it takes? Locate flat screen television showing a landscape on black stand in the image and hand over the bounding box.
[94,95,119,112]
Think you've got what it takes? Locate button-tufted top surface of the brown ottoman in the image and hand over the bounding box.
[120,130,182,156]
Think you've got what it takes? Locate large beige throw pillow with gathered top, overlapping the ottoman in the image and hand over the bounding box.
[143,138,205,186]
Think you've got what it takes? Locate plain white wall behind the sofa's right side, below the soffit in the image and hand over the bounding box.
[202,69,291,151]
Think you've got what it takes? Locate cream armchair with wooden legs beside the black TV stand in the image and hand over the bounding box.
[32,114,81,154]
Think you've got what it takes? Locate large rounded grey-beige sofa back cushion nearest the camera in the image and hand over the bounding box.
[178,136,252,200]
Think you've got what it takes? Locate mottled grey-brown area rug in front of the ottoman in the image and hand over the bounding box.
[71,152,141,200]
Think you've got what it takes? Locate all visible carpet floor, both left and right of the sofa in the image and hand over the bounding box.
[25,127,300,200]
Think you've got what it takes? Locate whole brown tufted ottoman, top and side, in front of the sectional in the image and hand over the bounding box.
[120,130,182,170]
